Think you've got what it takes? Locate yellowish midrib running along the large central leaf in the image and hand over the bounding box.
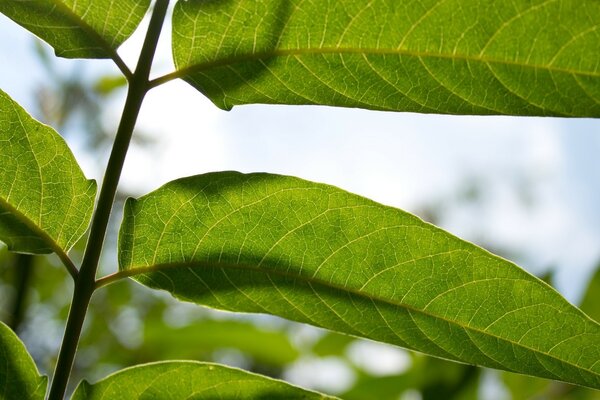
[117,262,600,387]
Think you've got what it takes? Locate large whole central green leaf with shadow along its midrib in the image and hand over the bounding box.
[119,172,600,388]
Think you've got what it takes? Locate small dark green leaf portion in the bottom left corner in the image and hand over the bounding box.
[0,322,48,400]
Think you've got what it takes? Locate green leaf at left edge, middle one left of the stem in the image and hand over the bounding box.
[0,91,96,256]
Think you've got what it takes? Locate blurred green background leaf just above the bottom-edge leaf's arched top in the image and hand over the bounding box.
[140,319,298,366]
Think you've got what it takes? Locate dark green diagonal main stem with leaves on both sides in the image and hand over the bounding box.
[48,0,169,400]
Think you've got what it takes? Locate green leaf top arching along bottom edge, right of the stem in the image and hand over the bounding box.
[73,361,333,400]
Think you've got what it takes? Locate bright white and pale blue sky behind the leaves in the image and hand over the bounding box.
[0,9,600,302]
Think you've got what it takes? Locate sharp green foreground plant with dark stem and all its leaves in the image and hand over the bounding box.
[0,0,600,399]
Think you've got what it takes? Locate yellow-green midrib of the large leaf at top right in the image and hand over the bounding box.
[169,47,600,79]
